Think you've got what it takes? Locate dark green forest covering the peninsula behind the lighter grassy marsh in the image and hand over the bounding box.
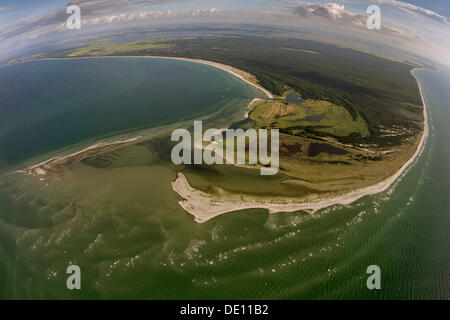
[146,37,422,146]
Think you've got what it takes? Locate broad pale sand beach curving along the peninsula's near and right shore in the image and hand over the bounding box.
[172,68,428,223]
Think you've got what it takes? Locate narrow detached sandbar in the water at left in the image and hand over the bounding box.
[16,136,141,176]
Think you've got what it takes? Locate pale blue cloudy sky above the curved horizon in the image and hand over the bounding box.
[0,0,450,65]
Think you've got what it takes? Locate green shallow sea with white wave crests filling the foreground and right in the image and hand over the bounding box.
[0,61,450,299]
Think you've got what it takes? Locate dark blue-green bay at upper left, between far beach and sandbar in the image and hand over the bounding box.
[0,57,260,169]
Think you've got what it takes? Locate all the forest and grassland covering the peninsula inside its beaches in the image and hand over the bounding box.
[41,36,423,210]
